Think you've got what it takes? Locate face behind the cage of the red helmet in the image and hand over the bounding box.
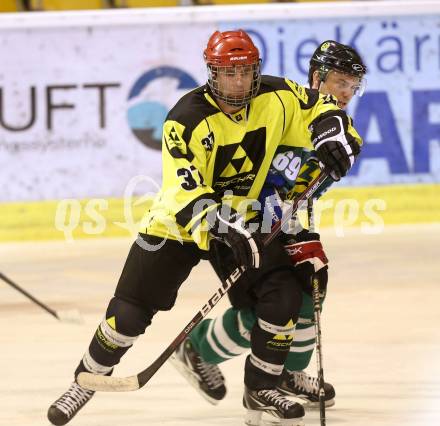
[217,65,255,104]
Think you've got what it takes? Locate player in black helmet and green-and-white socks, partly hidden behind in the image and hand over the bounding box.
[171,40,366,422]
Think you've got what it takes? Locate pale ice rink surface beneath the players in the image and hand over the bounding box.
[0,224,440,426]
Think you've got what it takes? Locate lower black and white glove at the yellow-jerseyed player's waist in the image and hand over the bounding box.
[207,206,263,268]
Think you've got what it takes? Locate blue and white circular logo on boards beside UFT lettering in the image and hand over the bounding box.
[127,66,199,150]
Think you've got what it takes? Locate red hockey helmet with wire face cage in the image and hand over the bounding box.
[203,30,261,107]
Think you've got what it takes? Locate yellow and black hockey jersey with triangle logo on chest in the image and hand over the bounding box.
[142,76,361,250]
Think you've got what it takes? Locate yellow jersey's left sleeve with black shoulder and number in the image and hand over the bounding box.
[142,88,221,250]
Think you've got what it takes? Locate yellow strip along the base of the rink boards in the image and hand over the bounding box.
[0,184,440,241]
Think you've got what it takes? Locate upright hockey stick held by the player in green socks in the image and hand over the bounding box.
[307,198,326,426]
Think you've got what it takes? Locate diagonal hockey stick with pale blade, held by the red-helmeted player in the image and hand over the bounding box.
[76,170,328,392]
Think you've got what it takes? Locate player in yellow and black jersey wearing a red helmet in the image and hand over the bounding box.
[48,30,361,426]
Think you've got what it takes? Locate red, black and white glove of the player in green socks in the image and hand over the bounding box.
[284,229,328,295]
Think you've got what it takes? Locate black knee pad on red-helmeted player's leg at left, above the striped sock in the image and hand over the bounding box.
[105,297,157,336]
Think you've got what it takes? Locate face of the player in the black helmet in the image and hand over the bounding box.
[313,70,361,109]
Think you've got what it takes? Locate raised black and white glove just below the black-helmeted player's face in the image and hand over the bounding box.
[312,115,361,181]
